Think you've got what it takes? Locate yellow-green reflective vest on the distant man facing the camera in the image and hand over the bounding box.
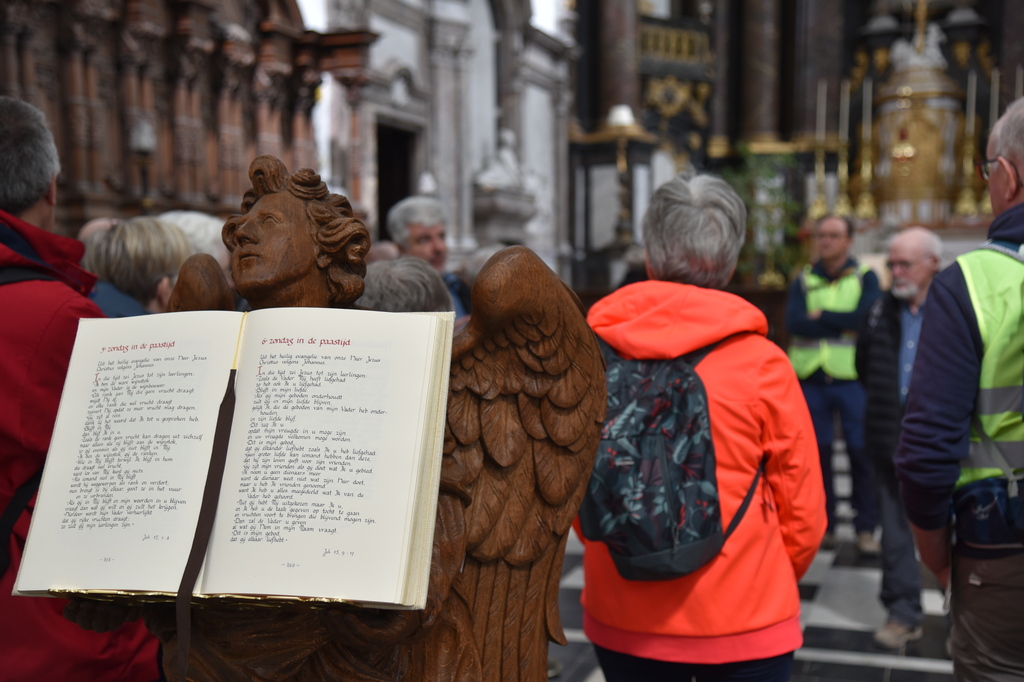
[790,265,869,379]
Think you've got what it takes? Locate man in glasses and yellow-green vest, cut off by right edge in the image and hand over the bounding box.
[896,99,1024,680]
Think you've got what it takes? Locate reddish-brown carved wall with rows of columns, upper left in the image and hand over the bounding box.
[0,0,364,235]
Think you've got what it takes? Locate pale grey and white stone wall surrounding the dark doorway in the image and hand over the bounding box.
[309,0,577,278]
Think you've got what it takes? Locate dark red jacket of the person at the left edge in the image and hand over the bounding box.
[0,211,159,682]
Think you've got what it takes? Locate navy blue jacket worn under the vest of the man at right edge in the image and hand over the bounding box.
[896,200,1024,548]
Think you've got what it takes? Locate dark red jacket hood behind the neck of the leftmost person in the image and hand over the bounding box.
[0,206,96,295]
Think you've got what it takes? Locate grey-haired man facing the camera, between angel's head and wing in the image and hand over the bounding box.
[387,195,471,318]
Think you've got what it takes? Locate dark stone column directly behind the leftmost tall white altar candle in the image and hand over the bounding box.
[793,0,844,139]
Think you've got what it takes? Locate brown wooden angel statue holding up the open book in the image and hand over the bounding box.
[122,157,605,682]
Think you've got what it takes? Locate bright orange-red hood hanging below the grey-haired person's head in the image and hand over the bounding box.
[587,281,768,359]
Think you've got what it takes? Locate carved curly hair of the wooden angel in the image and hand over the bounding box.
[221,156,370,307]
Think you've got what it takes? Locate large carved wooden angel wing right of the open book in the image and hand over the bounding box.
[444,247,606,680]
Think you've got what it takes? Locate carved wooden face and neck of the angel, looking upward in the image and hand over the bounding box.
[231,191,330,309]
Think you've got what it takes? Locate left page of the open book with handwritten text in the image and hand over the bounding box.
[15,311,242,592]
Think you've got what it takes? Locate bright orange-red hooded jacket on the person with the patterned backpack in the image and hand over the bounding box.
[583,282,826,664]
